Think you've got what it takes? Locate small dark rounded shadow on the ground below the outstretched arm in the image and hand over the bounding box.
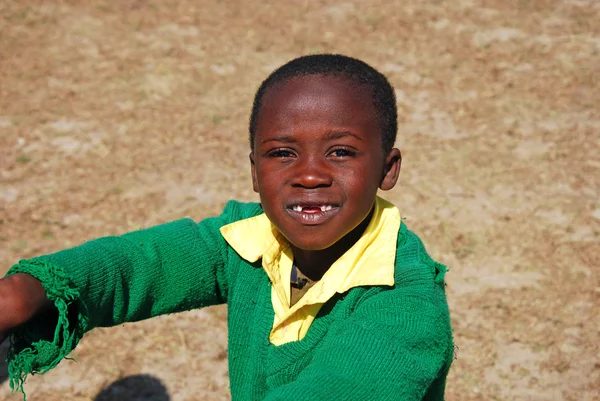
[94,375,170,401]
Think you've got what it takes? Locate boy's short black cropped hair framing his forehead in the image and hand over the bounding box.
[249,54,398,154]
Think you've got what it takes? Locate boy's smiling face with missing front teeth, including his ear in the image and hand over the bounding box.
[250,75,401,250]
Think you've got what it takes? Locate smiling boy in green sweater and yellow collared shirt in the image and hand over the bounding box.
[0,55,453,401]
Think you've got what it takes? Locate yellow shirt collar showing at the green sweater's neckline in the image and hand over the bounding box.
[221,196,401,345]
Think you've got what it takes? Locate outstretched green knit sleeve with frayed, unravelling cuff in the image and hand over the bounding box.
[7,203,255,390]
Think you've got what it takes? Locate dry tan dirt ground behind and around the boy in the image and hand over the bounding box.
[0,0,600,401]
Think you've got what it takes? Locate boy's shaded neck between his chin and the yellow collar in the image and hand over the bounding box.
[292,206,373,281]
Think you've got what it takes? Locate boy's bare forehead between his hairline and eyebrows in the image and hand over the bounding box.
[257,75,379,133]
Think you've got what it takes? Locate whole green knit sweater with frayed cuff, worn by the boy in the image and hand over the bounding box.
[8,201,453,401]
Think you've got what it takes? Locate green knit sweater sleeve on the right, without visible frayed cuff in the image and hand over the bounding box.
[264,265,453,401]
